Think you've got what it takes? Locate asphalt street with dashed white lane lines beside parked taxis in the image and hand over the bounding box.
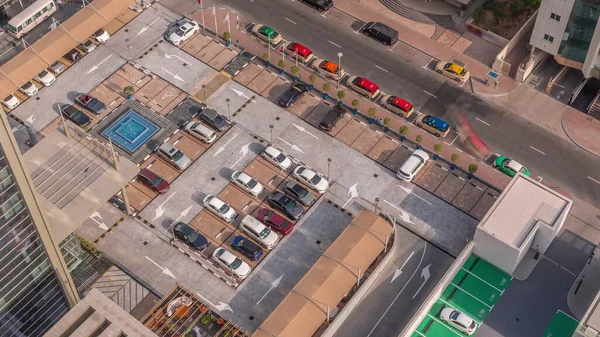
[161,0,600,204]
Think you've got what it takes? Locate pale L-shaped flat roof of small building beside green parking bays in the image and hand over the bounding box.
[479,173,572,247]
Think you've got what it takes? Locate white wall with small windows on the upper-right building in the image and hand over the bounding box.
[530,0,575,56]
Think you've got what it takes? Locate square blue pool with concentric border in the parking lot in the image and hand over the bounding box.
[102,109,160,153]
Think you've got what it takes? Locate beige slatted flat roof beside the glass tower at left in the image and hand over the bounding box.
[23,125,140,242]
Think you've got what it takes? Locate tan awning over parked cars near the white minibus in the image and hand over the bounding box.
[0,0,135,99]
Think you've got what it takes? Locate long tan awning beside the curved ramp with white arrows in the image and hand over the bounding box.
[252,210,393,337]
